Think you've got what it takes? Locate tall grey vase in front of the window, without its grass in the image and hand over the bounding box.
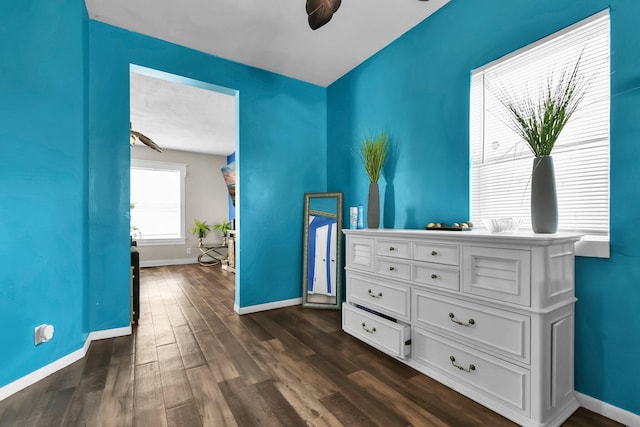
[531,156,558,233]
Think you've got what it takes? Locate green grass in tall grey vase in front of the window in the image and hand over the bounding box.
[497,58,587,233]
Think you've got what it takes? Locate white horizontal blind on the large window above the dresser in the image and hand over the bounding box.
[470,11,610,235]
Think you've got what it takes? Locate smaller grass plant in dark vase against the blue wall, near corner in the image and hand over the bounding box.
[360,133,388,228]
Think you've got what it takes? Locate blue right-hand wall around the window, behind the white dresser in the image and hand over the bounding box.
[327,0,640,414]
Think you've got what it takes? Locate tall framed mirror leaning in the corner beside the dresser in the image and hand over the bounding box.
[302,193,342,309]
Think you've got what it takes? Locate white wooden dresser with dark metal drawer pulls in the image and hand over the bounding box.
[342,230,581,426]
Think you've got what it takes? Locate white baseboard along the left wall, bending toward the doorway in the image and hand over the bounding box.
[0,326,131,401]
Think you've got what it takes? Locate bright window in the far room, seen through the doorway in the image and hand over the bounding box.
[131,159,187,245]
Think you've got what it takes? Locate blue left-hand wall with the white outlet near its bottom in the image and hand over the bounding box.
[0,0,88,386]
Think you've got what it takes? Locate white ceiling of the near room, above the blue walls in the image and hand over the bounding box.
[85,0,449,86]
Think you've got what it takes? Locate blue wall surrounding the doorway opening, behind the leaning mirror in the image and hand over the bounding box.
[89,21,327,318]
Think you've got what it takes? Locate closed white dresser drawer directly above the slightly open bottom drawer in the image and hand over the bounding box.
[347,273,411,321]
